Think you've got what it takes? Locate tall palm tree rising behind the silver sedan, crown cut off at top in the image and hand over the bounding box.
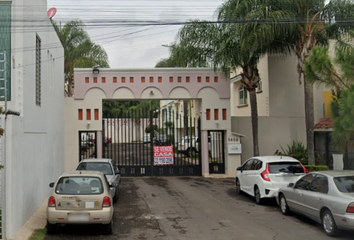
[276,0,354,165]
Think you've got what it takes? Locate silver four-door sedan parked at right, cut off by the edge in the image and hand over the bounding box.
[277,170,354,236]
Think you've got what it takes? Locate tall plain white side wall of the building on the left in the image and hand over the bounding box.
[2,0,65,239]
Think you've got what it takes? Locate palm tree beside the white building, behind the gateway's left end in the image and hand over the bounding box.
[52,20,109,97]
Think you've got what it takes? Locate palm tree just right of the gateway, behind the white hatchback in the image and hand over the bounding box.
[162,0,290,156]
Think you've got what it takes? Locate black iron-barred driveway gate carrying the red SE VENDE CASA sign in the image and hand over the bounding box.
[102,109,201,176]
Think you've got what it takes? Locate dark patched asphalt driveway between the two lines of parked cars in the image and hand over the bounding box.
[45,177,354,240]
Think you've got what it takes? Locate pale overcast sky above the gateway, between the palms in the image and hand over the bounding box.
[47,0,224,68]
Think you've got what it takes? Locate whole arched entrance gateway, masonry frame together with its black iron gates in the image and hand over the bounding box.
[65,68,241,177]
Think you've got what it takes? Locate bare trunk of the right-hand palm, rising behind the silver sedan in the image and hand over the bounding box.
[304,77,315,165]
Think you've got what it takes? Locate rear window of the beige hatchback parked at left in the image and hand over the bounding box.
[55,176,103,195]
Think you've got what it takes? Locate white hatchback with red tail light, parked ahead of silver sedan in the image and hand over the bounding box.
[235,156,308,204]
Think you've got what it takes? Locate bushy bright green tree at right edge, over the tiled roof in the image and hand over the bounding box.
[304,31,354,150]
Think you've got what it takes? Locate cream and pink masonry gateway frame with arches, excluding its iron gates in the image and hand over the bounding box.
[65,68,241,176]
